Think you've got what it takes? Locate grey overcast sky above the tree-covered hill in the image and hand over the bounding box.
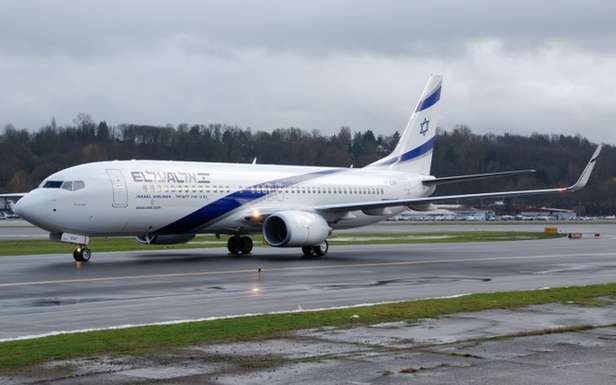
[0,0,616,144]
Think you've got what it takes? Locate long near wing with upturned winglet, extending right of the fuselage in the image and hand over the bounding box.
[315,145,601,212]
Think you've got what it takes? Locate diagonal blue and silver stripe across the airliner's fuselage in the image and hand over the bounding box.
[155,169,344,234]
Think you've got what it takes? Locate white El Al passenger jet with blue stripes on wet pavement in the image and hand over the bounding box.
[13,75,601,261]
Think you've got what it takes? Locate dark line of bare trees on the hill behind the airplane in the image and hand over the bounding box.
[0,114,616,215]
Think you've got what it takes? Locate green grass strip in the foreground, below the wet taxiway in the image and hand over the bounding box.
[0,283,616,371]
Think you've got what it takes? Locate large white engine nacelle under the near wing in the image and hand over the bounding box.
[263,211,331,247]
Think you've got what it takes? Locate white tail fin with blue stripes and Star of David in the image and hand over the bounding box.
[366,75,443,175]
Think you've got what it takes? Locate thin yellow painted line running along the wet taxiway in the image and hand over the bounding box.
[0,252,616,288]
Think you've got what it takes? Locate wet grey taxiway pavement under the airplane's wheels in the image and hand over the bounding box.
[0,225,616,339]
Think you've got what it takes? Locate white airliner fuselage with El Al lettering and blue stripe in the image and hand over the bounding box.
[20,160,434,236]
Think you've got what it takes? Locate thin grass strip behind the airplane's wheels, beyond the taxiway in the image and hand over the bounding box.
[0,231,564,256]
